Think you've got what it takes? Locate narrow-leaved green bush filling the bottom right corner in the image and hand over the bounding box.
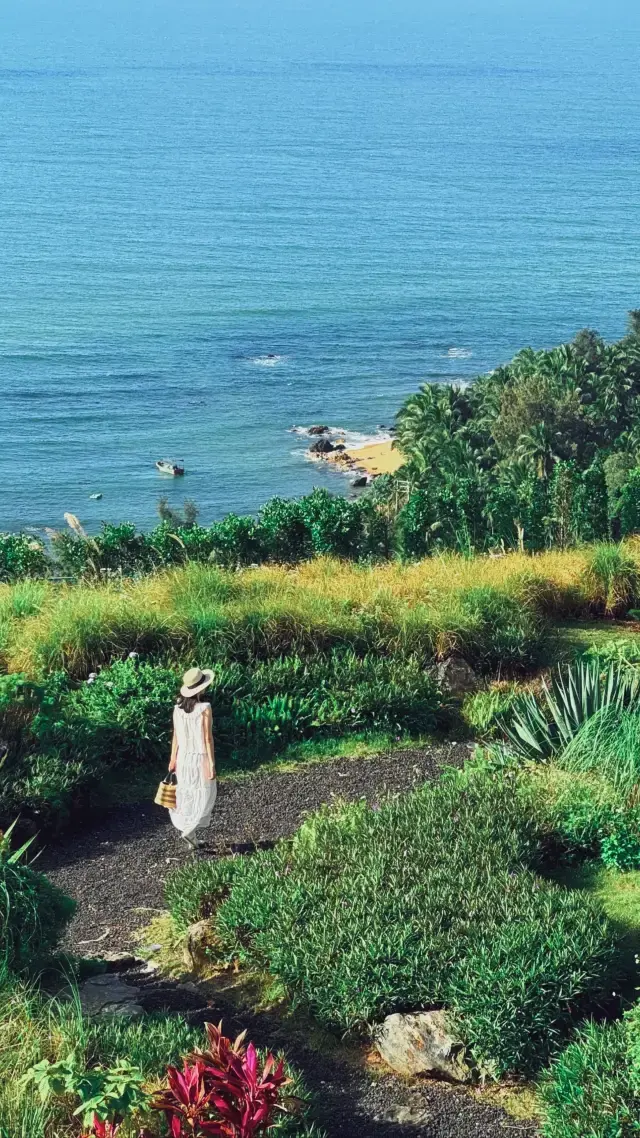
[541,1023,640,1138]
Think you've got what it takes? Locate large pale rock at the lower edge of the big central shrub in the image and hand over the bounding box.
[374,1012,471,1082]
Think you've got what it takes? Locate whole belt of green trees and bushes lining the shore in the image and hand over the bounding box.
[6,311,640,582]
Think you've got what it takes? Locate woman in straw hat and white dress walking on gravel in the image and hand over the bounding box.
[169,668,218,849]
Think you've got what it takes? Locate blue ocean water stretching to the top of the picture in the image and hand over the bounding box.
[0,0,640,530]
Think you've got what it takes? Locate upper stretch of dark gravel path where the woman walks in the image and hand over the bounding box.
[38,743,469,956]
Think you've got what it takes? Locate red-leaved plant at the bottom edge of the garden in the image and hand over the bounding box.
[154,1023,290,1138]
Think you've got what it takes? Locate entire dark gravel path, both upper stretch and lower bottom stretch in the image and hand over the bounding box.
[38,743,536,1138]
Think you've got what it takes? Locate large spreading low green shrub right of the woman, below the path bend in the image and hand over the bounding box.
[170,772,615,1074]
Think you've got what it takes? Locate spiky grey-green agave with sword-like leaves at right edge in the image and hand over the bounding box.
[500,660,640,759]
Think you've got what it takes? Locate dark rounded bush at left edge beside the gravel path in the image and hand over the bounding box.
[0,826,75,979]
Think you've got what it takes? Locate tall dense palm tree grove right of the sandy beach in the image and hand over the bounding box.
[387,318,640,556]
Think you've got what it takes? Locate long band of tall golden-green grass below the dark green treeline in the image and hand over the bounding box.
[0,541,640,675]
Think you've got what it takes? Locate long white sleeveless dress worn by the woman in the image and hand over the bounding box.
[169,703,218,836]
